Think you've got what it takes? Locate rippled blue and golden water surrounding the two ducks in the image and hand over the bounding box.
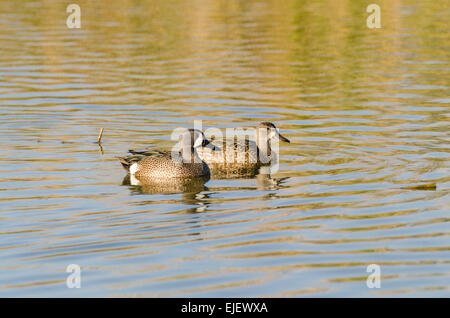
[0,0,450,297]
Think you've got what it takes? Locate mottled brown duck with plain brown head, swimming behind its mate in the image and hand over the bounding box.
[197,121,290,176]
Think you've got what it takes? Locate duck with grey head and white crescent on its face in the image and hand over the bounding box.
[117,129,219,183]
